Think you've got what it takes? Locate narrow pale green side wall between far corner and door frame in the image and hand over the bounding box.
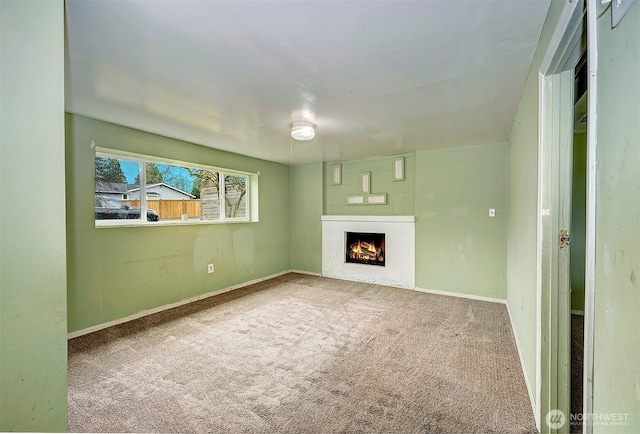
[507,1,564,406]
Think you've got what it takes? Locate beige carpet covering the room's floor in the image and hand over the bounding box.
[69,274,537,433]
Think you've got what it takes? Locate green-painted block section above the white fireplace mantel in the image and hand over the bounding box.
[324,154,416,215]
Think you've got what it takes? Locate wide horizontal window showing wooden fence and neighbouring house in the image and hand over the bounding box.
[95,150,257,226]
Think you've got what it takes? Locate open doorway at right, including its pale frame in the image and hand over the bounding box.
[536,0,596,433]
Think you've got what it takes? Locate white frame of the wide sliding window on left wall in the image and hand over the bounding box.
[94,147,259,228]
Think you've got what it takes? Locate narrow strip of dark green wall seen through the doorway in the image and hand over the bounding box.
[571,133,587,311]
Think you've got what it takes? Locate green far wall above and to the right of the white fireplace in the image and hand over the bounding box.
[318,147,507,299]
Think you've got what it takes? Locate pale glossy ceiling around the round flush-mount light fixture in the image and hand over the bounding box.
[65,0,549,163]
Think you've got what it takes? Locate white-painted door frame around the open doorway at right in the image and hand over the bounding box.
[535,0,597,434]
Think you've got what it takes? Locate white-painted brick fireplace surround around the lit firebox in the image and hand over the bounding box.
[322,215,415,289]
